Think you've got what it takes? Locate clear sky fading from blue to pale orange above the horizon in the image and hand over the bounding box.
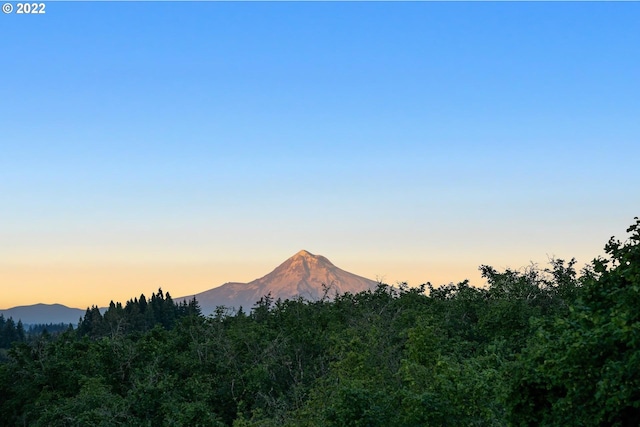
[0,1,640,308]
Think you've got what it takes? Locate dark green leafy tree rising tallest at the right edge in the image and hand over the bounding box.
[508,218,640,426]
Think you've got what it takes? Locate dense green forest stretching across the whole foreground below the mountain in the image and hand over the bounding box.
[0,218,640,427]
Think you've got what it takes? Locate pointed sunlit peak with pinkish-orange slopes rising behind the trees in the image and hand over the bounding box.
[175,250,377,315]
